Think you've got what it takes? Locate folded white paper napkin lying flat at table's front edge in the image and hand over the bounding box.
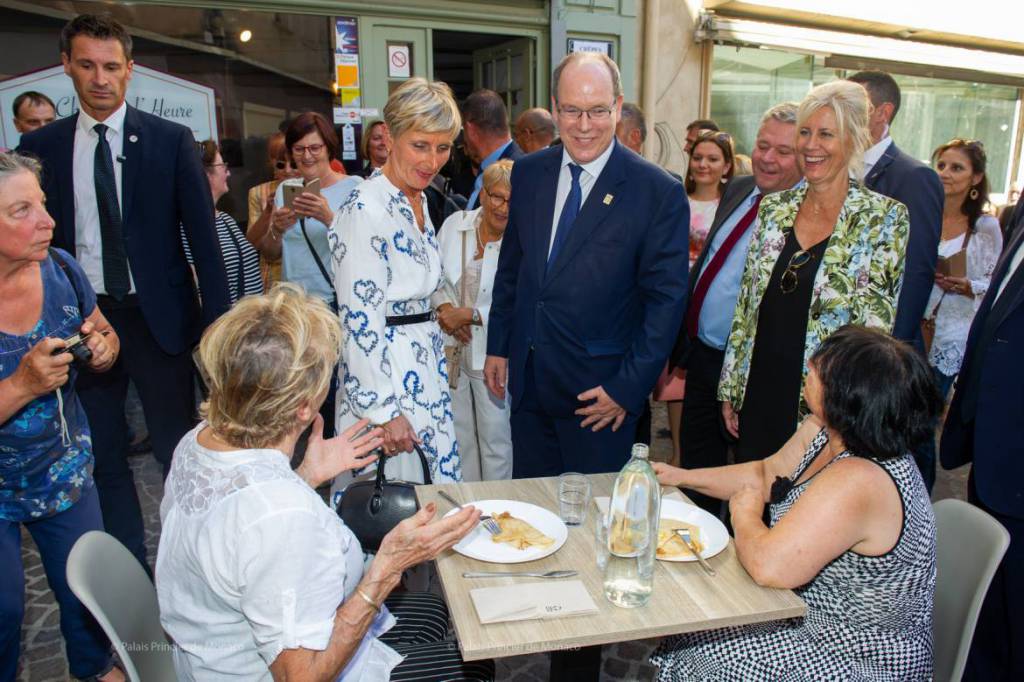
[469,581,597,624]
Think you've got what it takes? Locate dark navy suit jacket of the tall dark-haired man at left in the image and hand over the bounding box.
[18,106,230,354]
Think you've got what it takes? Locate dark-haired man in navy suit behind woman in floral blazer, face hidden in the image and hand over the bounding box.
[850,71,945,342]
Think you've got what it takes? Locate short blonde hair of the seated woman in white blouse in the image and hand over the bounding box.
[199,283,341,447]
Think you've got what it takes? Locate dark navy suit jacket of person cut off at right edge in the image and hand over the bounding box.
[940,225,1024,519]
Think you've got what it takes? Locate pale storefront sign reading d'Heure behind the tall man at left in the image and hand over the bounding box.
[0,63,217,148]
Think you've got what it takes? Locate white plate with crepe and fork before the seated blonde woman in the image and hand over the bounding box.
[445,500,569,563]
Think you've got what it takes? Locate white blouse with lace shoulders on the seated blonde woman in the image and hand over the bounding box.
[157,423,401,682]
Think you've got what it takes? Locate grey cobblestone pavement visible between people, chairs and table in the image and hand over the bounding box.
[18,403,968,682]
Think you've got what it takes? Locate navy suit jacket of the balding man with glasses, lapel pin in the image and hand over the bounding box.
[487,142,689,417]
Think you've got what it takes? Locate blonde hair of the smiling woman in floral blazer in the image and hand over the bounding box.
[797,81,871,180]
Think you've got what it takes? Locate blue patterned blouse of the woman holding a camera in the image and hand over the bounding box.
[0,251,96,521]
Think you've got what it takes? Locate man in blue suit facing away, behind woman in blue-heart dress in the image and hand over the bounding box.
[462,88,523,211]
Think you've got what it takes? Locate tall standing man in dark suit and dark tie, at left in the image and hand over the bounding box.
[20,14,229,565]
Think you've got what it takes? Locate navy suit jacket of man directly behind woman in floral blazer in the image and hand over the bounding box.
[864,142,945,339]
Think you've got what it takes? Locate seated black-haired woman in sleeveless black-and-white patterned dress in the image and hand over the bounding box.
[652,326,942,680]
